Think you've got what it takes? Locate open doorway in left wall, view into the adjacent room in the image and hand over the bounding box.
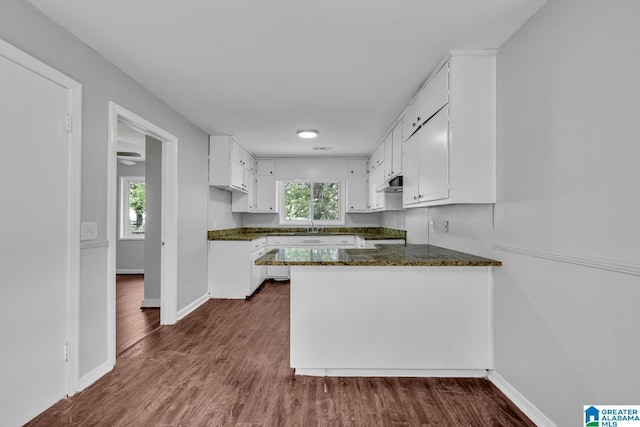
[115,120,162,355]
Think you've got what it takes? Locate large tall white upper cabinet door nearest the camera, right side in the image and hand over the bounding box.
[418,107,449,202]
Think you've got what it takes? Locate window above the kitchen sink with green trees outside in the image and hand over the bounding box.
[280,181,344,226]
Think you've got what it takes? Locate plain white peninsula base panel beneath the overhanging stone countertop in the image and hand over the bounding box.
[291,265,493,377]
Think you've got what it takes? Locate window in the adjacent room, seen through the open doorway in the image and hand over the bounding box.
[120,176,145,239]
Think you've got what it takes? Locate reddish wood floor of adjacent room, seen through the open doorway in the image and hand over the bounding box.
[116,274,160,354]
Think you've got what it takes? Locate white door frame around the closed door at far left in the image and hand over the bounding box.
[0,39,82,396]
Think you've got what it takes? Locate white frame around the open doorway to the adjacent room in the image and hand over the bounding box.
[107,101,178,365]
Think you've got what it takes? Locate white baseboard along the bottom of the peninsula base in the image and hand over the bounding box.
[295,368,487,378]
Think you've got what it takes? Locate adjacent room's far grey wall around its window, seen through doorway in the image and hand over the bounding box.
[115,162,145,273]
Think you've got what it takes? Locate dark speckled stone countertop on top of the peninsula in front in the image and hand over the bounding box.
[255,245,502,267]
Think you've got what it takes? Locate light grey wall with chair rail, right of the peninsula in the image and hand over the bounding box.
[494,0,640,426]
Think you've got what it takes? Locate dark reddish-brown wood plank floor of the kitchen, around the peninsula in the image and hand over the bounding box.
[28,282,533,426]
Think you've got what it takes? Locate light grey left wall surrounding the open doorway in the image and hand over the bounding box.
[0,0,208,382]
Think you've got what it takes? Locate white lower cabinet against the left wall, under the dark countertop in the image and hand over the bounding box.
[209,237,267,299]
